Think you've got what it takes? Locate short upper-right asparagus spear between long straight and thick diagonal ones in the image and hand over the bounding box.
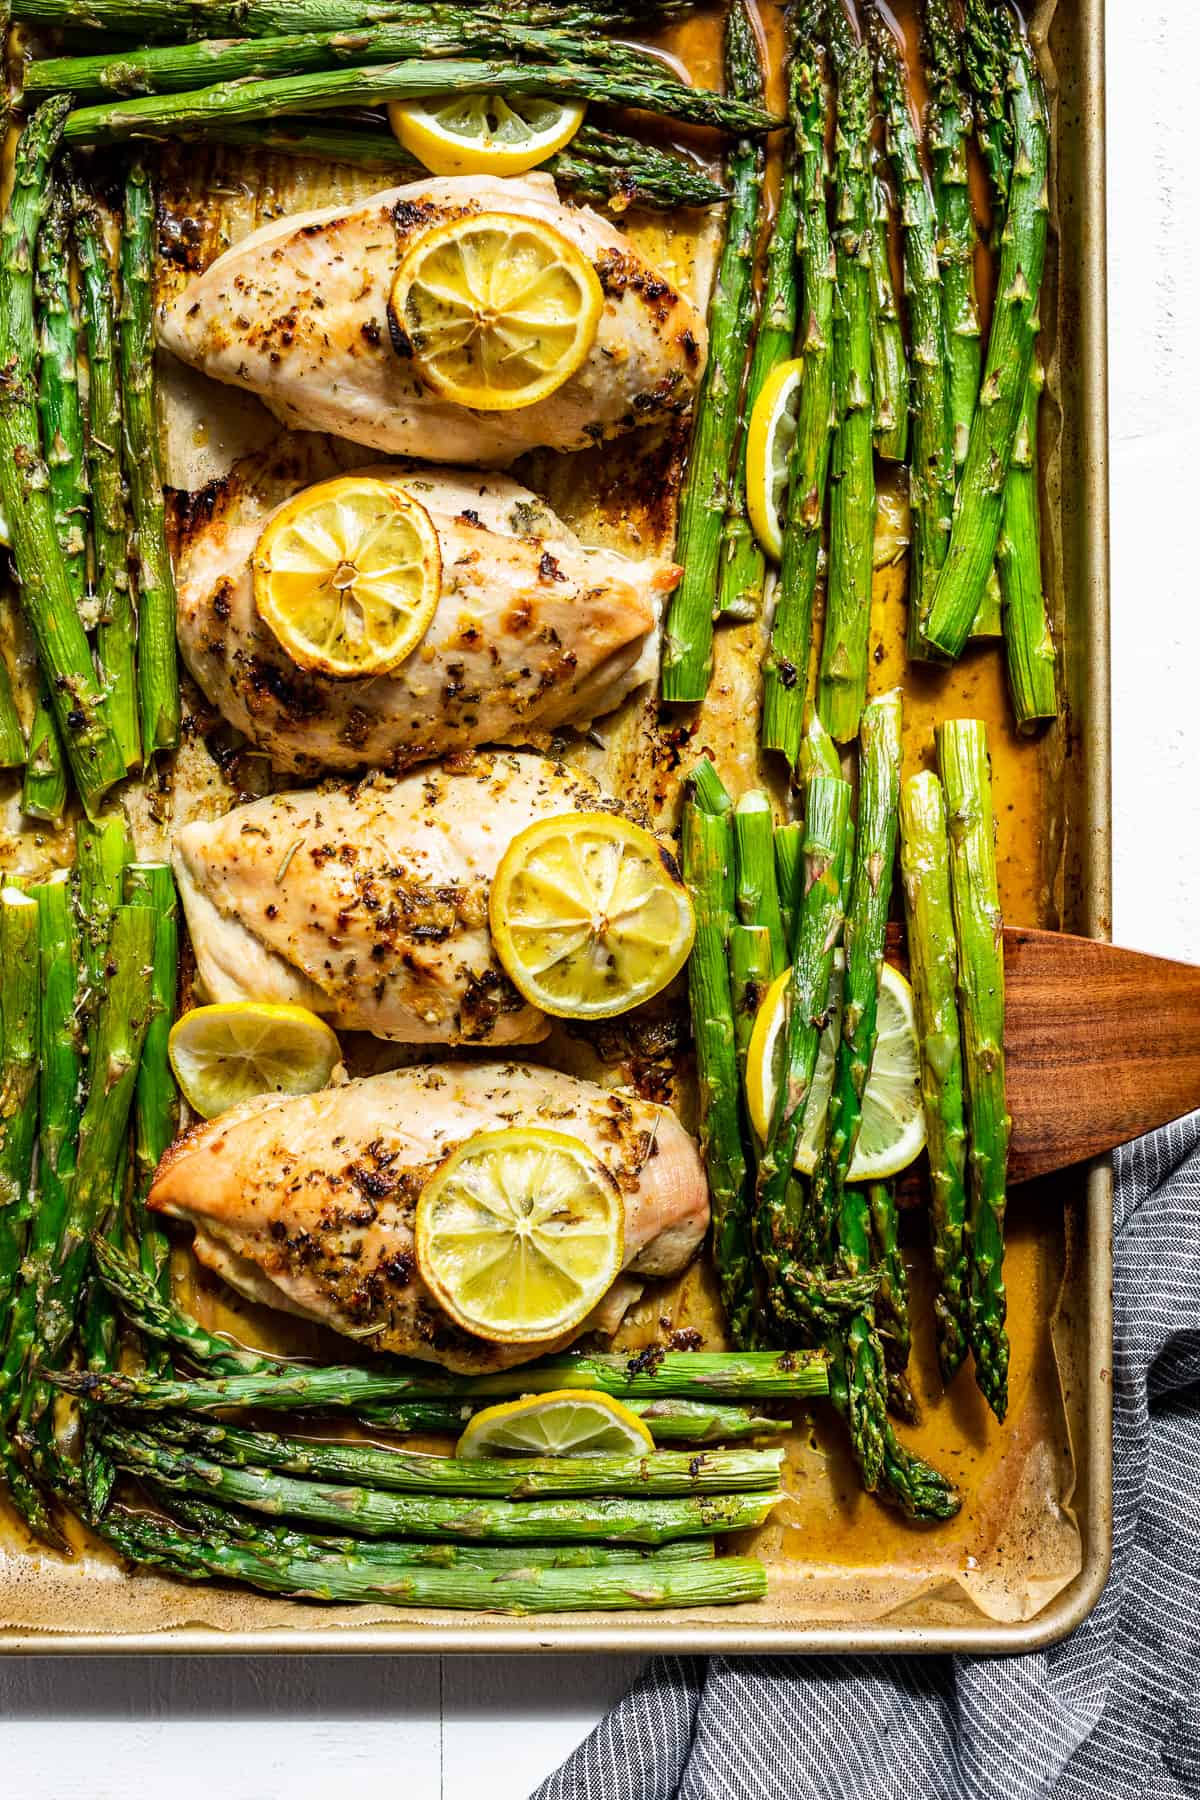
[921,0,982,470]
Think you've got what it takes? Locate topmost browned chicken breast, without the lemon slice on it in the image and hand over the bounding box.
[158,175,705,468]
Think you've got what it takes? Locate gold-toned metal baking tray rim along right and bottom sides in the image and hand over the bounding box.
[0,0,1112,1654]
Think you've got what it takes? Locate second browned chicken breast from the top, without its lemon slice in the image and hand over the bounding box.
[178,450,678,774]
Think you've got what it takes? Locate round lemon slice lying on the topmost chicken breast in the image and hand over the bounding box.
[390,212,604,412]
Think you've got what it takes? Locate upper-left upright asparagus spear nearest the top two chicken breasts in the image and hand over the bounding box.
[119,160,180,760]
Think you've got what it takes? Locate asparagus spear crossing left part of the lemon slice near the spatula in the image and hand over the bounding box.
[756,776,849,1288]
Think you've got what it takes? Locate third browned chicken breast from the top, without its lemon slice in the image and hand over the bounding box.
[175,752,626,1046]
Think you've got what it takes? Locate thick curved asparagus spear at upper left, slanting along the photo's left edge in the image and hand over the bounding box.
[0,101,124,812]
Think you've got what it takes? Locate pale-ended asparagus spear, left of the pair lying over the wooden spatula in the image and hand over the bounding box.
[900,774,968,1382]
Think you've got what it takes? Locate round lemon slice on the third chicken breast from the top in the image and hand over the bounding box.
[489,812,696,1019]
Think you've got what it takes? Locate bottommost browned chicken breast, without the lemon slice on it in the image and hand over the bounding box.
[149,1062,709,1372]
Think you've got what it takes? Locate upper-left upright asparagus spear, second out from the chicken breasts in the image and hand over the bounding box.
[72,184,142,769]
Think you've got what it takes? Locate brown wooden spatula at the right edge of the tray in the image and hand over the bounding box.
[1004,927,1200,1181]
